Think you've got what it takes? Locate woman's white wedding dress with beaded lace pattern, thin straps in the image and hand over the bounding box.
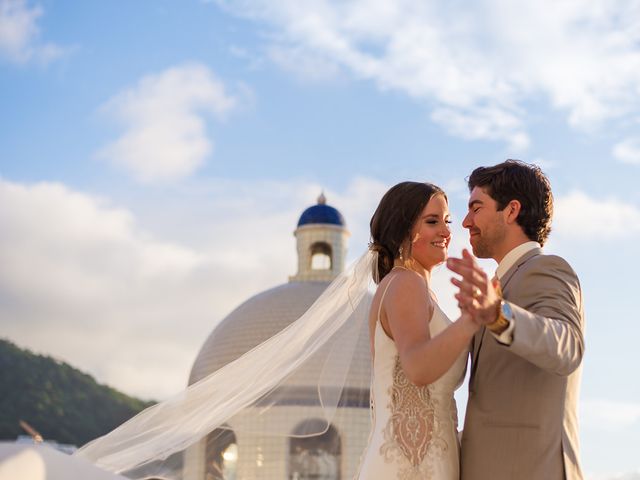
[356,282,467,480]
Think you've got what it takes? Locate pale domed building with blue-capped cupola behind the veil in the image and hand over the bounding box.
[184,194,371,480]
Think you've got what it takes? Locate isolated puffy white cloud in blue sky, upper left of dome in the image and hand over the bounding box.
[99,63,237,182]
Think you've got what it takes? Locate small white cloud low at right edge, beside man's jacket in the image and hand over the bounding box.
[580,399,640,432]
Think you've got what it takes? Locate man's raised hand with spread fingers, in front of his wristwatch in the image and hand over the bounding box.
[447,249,501,325]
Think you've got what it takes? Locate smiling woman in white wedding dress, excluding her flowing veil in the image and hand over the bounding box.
[358,182,479,480]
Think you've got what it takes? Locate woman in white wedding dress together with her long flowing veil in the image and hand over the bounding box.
[76,182,479,480]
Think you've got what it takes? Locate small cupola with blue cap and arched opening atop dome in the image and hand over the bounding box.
[289,193,349,282]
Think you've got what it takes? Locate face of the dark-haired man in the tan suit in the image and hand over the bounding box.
[462,187,506,258]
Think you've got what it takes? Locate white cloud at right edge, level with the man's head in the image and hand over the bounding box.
[553,191,640,241]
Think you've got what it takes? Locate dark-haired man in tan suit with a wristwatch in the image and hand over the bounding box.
[447,160,584,480]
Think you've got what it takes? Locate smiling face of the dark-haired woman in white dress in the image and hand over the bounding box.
[411,195,451,270]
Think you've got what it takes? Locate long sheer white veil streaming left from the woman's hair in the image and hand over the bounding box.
[76,251,377,480]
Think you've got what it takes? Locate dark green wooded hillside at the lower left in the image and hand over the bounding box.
[0,339,153,446]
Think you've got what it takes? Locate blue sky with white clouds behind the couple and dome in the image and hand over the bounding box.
[0,0,640,480]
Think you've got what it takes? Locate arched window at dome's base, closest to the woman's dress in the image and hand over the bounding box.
[289,419,342,480]
